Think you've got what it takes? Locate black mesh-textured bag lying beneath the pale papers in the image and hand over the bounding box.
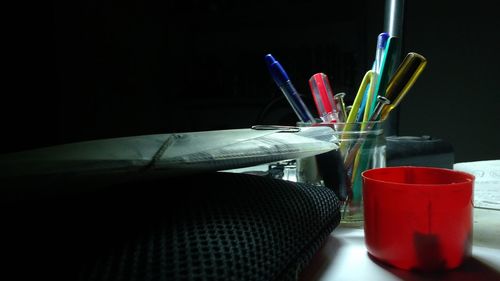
[7,172,340,280]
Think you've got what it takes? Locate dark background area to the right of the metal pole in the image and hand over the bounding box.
[400,0,500,162]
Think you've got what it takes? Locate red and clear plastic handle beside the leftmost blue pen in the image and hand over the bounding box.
[309,73,339,123]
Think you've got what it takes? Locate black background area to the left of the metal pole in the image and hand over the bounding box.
[2,0,376,151]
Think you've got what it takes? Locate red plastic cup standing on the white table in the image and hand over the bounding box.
[362,166,474,271]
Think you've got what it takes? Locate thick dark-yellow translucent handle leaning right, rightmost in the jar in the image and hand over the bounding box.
[380,52,427,120]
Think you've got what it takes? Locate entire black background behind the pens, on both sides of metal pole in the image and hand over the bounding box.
[1,0,500,162]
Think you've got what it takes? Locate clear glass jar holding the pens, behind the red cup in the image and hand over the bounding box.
[296,121,386,227]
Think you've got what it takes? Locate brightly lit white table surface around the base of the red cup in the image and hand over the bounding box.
[299,208,500,281]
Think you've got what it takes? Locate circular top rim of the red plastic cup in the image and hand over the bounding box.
[361,166,475,188]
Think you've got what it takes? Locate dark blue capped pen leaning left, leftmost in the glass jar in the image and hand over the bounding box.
[265,54,315,122]
